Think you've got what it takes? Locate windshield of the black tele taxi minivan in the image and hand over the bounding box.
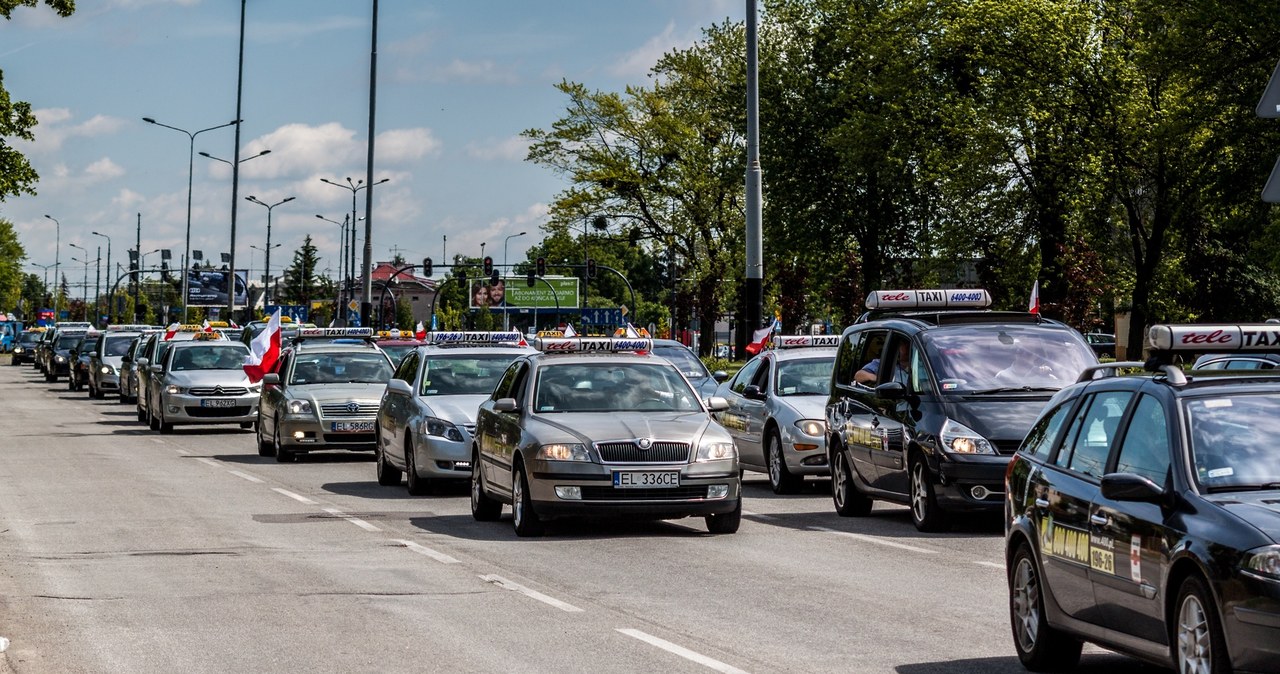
[924,324,1097,394]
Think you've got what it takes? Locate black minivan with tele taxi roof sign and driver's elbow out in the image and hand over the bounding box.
[826,289,1097,531]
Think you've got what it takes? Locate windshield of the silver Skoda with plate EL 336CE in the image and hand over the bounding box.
[534,362,701,413]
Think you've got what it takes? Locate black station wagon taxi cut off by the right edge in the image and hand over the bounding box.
[1005,324,1280,674]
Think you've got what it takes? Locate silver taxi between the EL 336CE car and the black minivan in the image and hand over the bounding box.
[716,335,840,494]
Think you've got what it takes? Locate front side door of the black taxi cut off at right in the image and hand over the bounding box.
[1089,394,1183,643]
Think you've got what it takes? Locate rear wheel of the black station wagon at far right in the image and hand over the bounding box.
[1009,544,1082,671]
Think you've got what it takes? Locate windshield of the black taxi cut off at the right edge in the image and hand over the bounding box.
[1185,393,1280,491]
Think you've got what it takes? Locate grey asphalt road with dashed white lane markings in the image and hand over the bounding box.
[0,361,1156,674]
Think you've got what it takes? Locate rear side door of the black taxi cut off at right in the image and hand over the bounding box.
[1032,390,1133,624]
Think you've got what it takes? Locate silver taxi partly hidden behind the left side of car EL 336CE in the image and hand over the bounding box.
[376,333,534,496]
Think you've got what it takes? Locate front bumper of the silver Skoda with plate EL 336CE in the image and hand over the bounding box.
[527,459,741,519]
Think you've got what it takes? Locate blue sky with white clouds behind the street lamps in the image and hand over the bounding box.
[0,0,746,294]
